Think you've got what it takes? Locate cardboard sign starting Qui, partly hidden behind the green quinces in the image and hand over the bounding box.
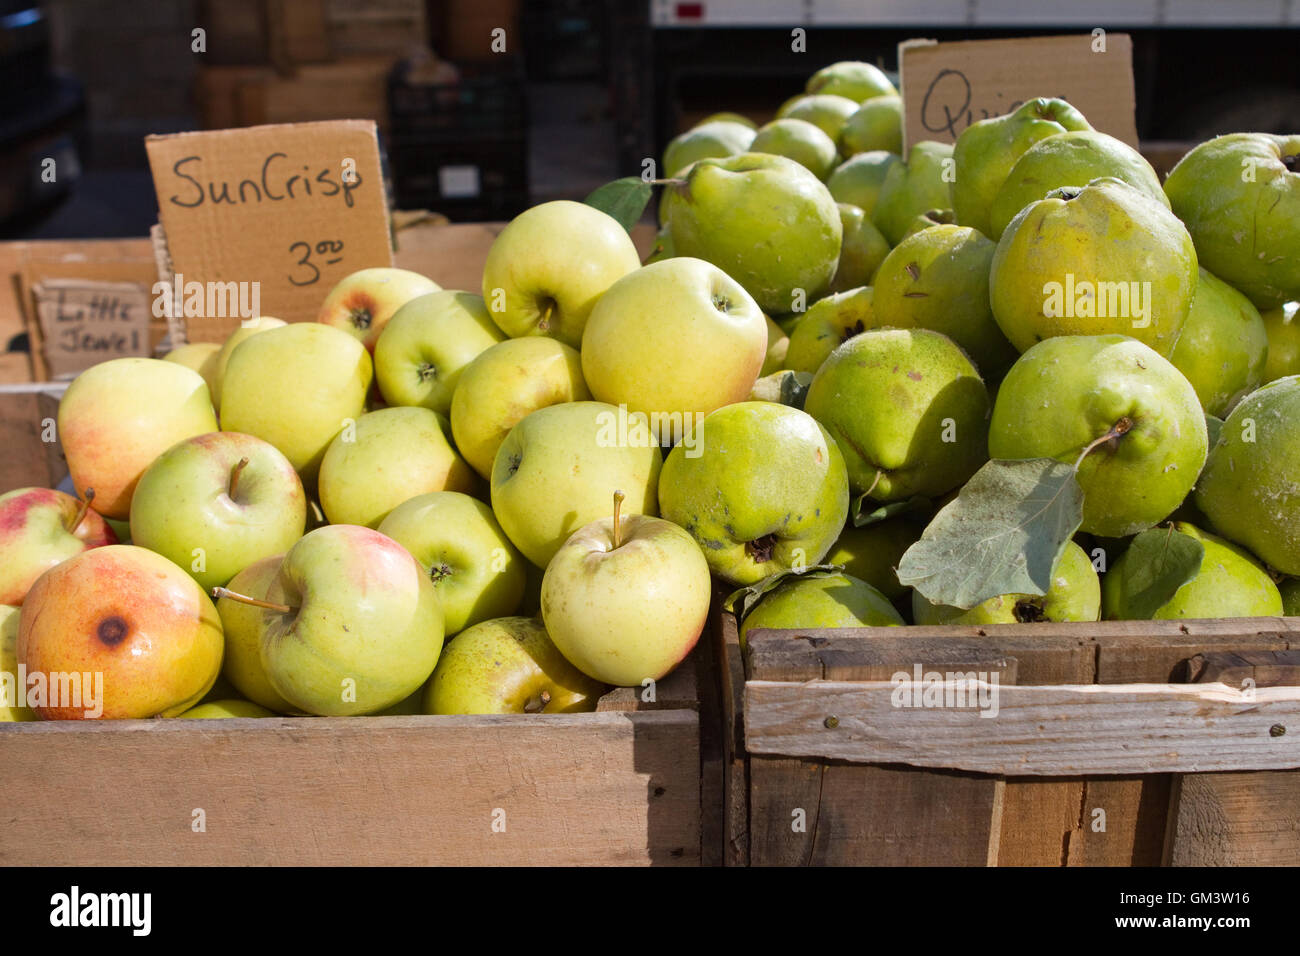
[898,34,1138,151]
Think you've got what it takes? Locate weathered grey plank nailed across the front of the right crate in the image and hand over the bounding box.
[745,680,1300,777]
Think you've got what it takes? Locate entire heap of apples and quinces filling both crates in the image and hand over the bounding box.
[0,62,1300,718]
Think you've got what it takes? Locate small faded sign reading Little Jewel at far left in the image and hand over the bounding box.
[33,278,152,380]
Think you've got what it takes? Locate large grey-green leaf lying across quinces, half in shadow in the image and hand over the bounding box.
[898,458,1083,610]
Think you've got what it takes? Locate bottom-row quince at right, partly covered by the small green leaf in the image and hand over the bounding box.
[1101,522,1283,620]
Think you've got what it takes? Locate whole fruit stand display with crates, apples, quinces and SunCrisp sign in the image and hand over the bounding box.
[0,41,1300,865]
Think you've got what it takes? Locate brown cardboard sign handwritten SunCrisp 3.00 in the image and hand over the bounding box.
[144,120,393,342]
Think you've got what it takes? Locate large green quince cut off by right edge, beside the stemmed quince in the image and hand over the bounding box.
[1195,376,1300,575]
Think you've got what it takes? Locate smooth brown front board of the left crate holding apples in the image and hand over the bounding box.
[0,710,699,866]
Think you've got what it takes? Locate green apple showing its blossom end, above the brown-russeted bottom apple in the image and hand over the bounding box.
[378,492,527,637]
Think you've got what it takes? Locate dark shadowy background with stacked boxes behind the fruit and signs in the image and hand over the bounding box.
[0,0,1300,238]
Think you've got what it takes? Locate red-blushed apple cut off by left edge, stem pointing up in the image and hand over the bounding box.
[0,488,117,605]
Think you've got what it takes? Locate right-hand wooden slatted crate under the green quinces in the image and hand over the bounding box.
[712,614,1300,866]
